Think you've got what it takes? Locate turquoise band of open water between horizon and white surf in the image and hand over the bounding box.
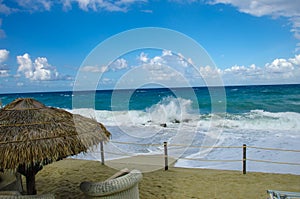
[0,85,300,114]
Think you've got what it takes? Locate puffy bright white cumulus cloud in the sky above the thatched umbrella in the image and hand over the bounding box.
[17,53,62,81]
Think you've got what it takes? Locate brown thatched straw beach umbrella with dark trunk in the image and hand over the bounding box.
[0,98,110,194]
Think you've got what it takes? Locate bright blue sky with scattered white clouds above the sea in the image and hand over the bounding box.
[0,0,300,93]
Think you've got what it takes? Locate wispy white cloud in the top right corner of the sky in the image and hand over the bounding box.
[209,0,300,44]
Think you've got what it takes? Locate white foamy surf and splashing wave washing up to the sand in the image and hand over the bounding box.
[71,97,300,174]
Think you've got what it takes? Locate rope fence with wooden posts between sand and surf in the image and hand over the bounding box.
[100,141,300,174]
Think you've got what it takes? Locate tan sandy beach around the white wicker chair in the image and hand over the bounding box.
[27,159,300,199]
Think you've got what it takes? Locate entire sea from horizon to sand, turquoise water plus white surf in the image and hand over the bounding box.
[0,85,300,174]
